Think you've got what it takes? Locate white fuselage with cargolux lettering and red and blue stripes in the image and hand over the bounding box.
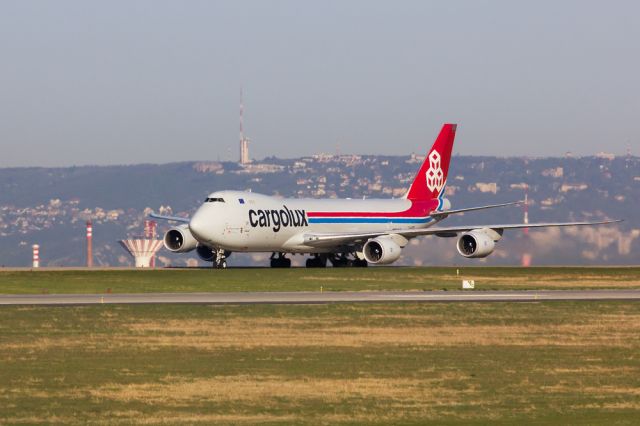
[189,191,450,253]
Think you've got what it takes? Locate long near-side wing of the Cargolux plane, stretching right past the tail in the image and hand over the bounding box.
[304,220,622,247]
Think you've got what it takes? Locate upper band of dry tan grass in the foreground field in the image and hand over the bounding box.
[7,314,640,355]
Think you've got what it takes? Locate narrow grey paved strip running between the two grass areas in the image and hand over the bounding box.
[0,290,640,306]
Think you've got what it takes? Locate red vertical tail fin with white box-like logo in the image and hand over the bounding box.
[406,124,457,200]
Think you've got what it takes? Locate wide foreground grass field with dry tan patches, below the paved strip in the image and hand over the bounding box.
[0,302,640,424]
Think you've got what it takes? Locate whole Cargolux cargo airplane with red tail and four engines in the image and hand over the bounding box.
[150,124,619,268]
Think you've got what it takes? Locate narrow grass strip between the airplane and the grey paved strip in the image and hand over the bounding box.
[0,267,640,294]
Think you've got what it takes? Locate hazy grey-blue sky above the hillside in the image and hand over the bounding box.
[0,0,640,167]
